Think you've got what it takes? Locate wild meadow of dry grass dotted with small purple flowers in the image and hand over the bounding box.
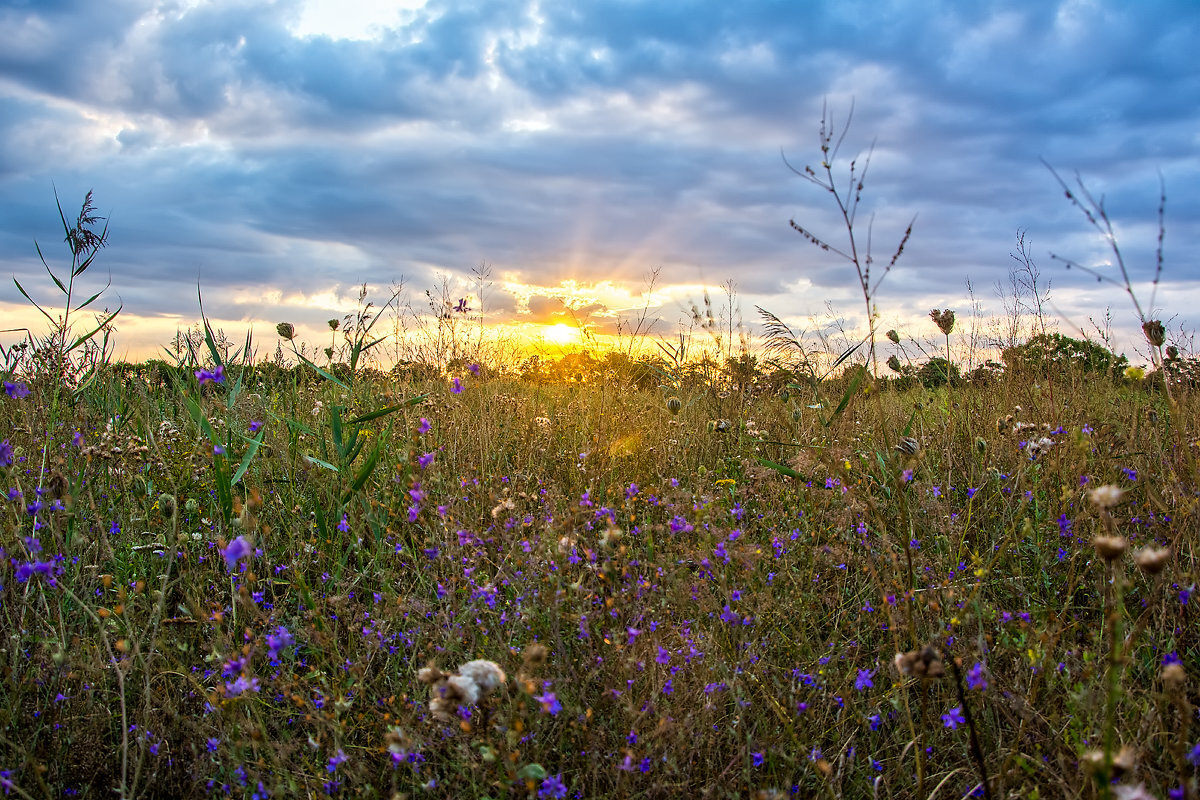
[0,160,1200,800]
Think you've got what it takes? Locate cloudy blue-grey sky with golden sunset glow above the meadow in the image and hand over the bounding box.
[0,0,1200,367]
